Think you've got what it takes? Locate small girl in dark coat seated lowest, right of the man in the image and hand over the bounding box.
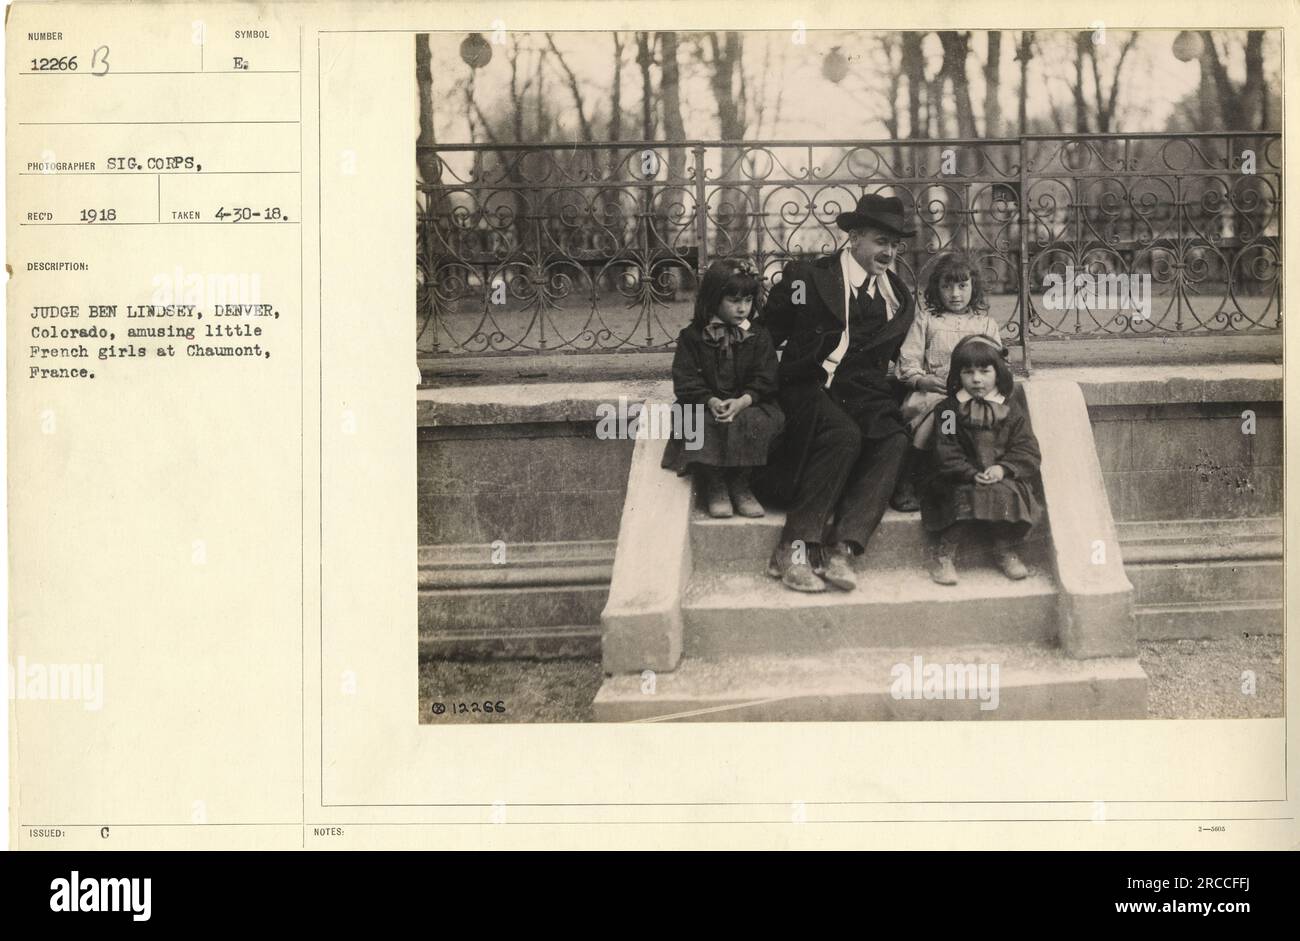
[920,334,1043,585]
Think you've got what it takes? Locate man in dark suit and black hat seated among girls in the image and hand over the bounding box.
[759,195,917,591]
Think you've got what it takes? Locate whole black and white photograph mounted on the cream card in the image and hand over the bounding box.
[412,27,1284,725]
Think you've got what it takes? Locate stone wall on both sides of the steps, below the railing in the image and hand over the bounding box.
[416,364,1283,658]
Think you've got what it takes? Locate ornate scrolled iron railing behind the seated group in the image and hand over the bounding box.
[416,131,1282,356]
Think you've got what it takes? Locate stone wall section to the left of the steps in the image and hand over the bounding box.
[416,383,660,658]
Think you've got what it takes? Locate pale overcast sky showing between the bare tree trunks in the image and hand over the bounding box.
[430,30,1281,143]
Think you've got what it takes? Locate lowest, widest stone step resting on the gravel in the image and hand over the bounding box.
[594,645,1147,721]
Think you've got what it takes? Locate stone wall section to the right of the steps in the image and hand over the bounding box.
[1052,364,1283,639]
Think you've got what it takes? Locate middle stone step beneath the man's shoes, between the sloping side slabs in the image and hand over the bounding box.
[683,567,1057,658]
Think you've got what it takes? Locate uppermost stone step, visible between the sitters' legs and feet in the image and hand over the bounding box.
[690,507,1049,574]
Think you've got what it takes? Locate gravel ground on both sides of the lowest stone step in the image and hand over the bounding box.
[420,634,1283,724]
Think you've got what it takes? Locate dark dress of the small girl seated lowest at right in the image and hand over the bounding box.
[920,390,1043,535]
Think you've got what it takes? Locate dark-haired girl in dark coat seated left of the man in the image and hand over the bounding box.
[663,259,785,516]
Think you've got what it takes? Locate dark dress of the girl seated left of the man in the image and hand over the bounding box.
[663,324,785,474]
